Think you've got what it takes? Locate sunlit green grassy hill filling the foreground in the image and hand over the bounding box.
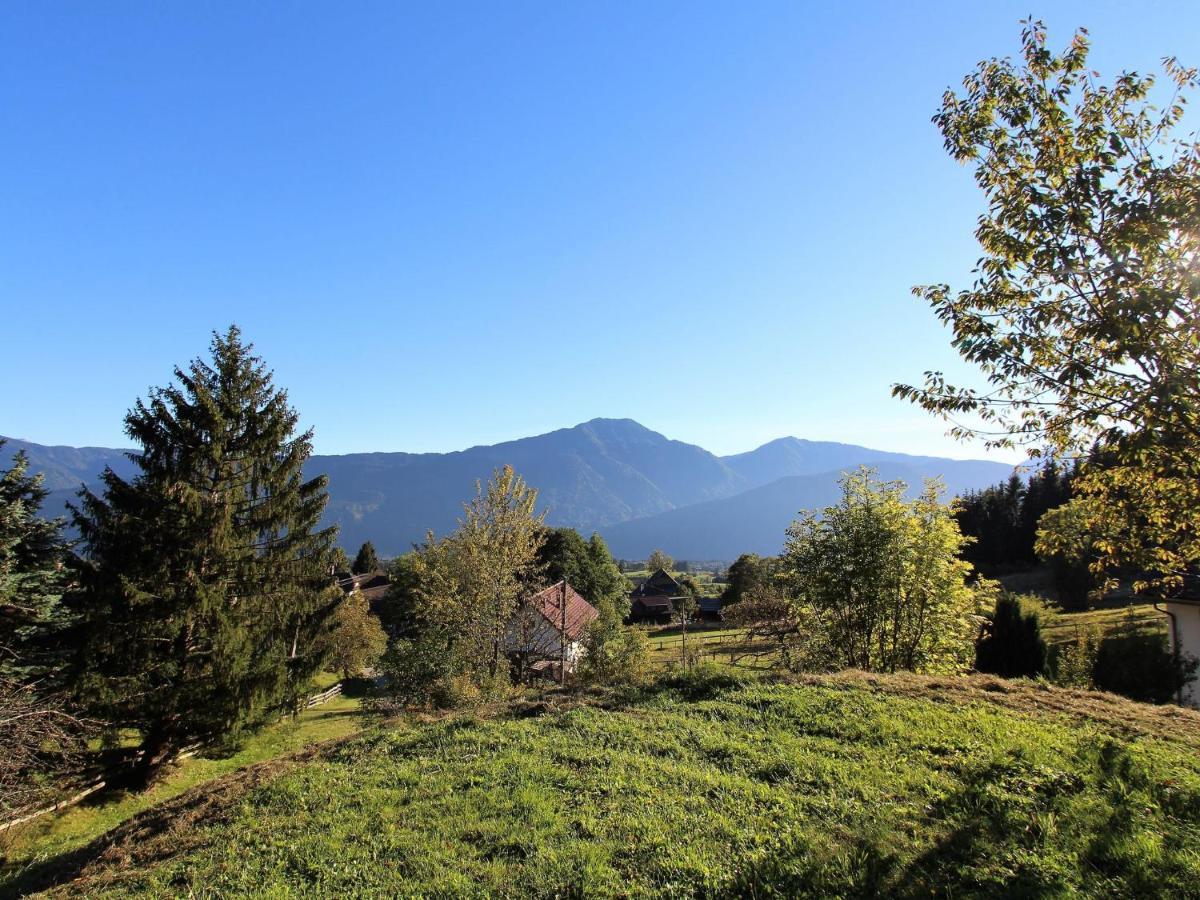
[7,670,1200,896]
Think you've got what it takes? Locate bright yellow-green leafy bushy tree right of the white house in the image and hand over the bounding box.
[782,468,978,672]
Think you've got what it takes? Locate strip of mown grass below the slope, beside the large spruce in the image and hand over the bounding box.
[0,691,362,893]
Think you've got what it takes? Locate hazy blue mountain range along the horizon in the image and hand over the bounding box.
[4,419,1013,559]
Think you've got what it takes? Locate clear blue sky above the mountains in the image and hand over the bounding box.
[0,0,1200,456]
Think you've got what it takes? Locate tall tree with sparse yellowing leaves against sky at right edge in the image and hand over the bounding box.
[894,22,1200,587]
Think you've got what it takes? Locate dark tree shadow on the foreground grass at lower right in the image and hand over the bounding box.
[719,742,1185,900]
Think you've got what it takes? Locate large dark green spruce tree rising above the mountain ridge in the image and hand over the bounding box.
[73,326,341,782]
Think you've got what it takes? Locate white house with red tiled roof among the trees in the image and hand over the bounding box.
[505,580,600,678]
